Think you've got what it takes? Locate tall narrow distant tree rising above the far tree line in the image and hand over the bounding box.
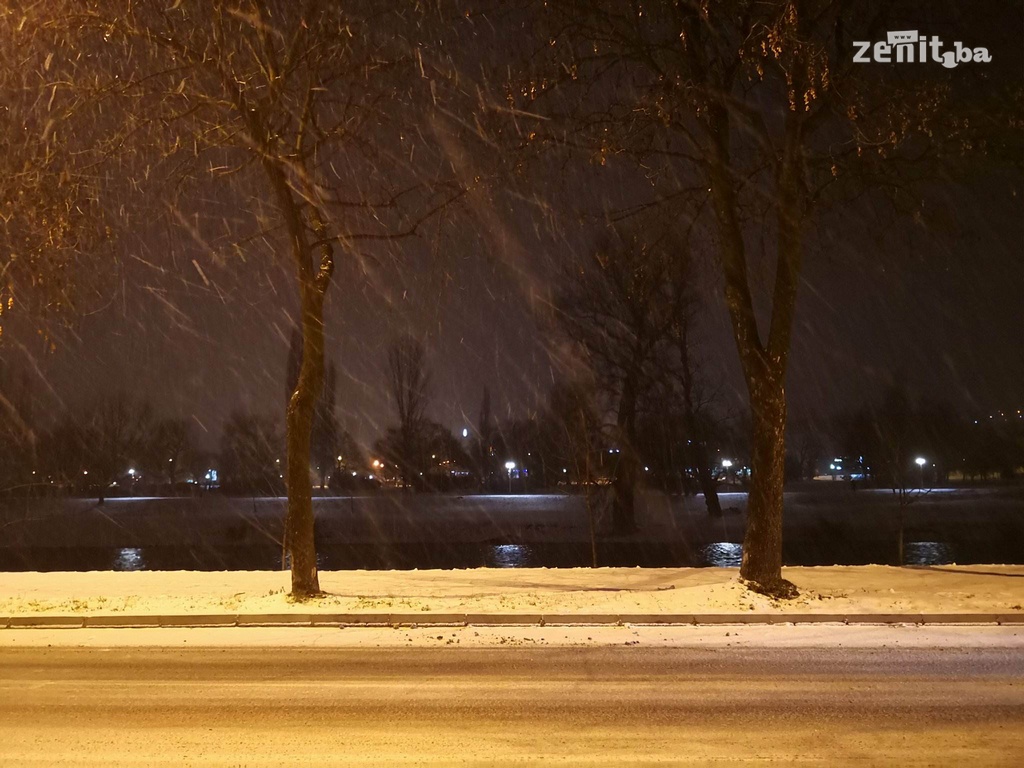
[387,336,430,487]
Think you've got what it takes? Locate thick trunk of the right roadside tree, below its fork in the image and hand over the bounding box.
[739,371,793,596]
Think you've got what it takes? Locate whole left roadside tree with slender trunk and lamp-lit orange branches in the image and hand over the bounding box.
[47,0,460,597]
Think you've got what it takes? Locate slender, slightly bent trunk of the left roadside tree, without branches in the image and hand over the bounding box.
[285,284,324,597]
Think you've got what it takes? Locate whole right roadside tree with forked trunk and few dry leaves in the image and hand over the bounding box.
[508,0,990,595]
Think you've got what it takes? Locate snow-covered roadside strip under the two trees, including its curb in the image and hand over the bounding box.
[0,565,1024,629]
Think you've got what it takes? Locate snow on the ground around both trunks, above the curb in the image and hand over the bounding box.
[0,565,1024,621]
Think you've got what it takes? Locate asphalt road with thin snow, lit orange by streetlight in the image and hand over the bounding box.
[0,647,1024,768]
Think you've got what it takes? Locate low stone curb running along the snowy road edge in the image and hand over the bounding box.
[0,611,1024,629]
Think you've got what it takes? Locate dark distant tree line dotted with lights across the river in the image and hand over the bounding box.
[6,354,1024,505]
